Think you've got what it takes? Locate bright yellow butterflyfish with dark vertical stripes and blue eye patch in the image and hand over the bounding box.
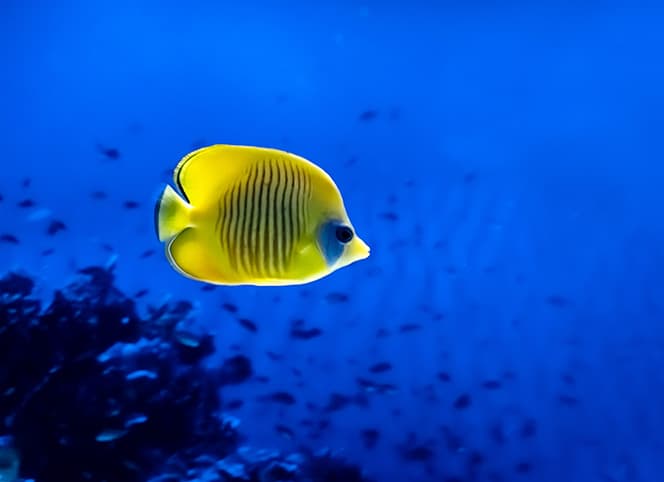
[155,145,369,286]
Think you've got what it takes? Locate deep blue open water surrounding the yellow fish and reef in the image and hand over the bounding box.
[0,0,664,482]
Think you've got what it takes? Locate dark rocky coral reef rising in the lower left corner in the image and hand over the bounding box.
[0,265,367,482]
